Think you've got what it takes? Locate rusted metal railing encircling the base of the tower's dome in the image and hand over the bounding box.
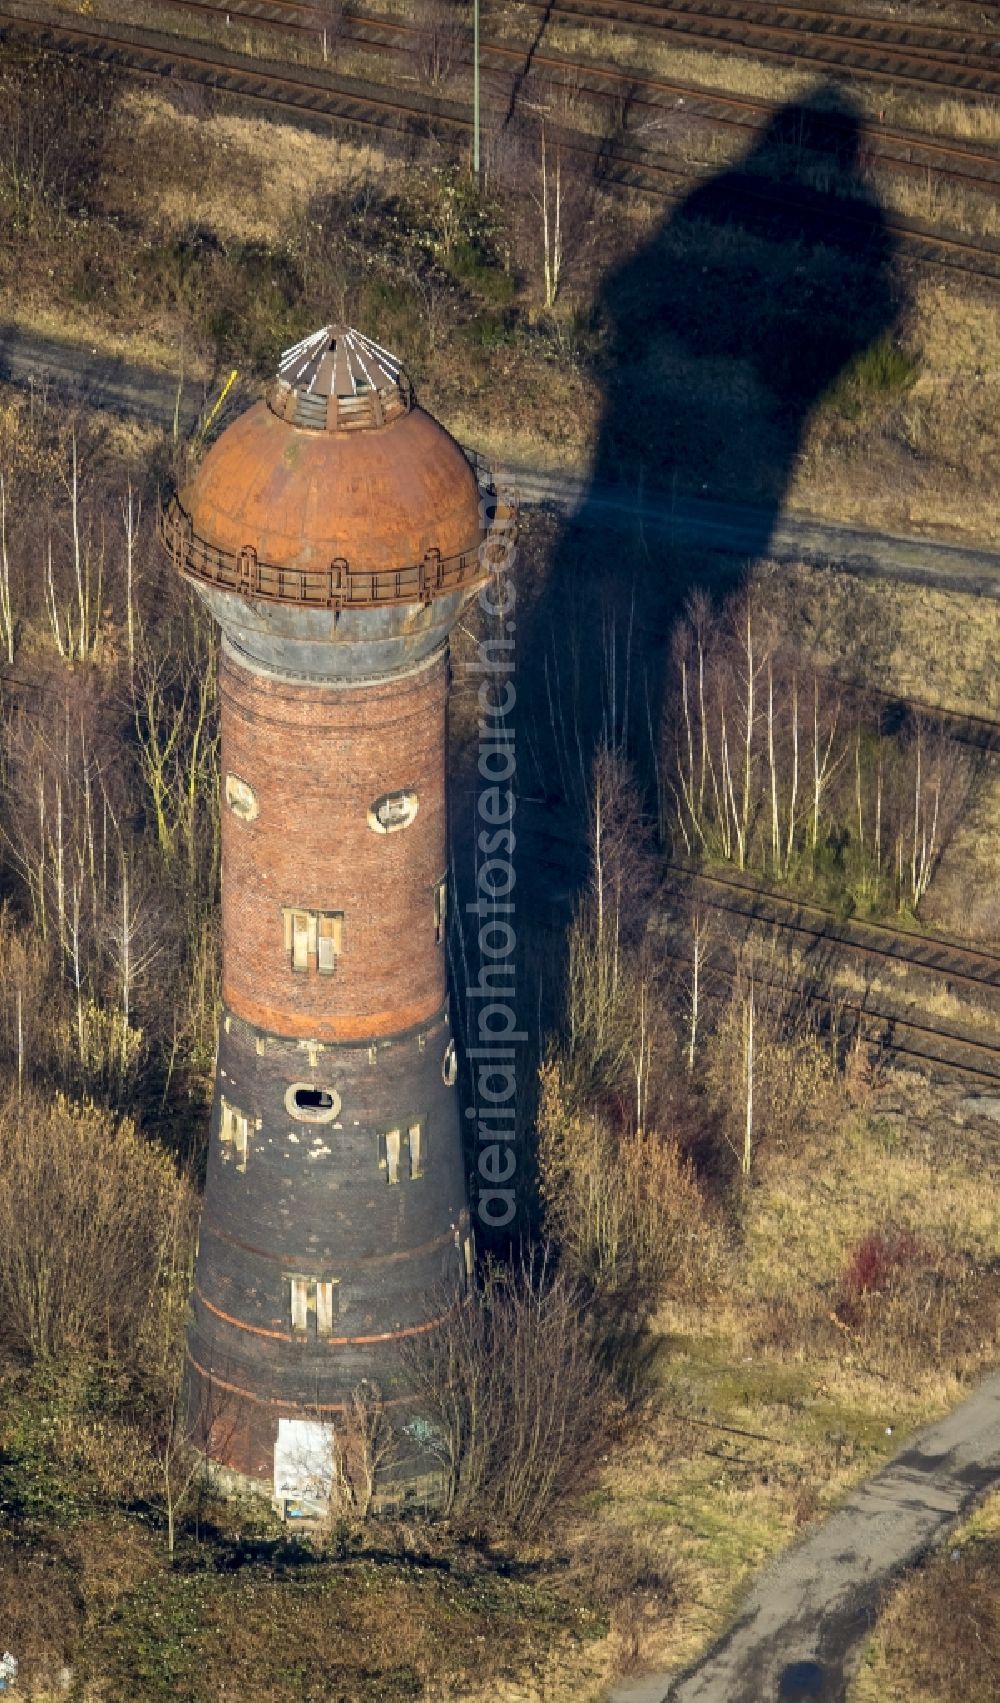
[157,492,516,610]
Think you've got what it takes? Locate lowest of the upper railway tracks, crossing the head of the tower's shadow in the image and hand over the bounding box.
[0,9,1000,284]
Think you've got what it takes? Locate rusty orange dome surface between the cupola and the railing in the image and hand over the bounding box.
[181,402,482,571]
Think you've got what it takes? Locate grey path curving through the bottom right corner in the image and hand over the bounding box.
[610,1373,1000,1703]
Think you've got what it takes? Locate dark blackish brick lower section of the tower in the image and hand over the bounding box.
[187,1012,468,1480]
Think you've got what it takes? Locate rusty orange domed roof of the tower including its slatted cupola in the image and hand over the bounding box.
[165,327,484,601]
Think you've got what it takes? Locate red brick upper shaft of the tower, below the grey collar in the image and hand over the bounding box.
[220,652,448,1041]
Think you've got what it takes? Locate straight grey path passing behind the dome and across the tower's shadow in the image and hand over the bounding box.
[0,324,1000,598]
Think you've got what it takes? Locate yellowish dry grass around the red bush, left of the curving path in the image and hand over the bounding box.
[579,1076,1000,1682]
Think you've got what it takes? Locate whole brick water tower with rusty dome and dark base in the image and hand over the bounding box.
[160,327,517,1497]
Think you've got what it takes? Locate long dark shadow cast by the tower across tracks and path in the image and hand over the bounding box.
[460,87,903,1239]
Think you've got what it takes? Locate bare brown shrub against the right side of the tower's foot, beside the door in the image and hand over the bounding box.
[405,1260,615,1538]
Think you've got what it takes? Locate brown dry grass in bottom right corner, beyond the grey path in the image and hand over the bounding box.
[848,1495,1000,1703]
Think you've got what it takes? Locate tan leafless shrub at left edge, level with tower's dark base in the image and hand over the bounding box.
[0,1092,194,1364]
